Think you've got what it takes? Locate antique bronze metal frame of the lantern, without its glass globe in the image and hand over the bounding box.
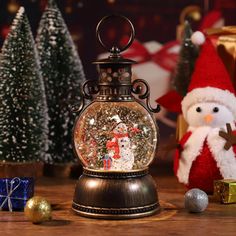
[72,15,160,219]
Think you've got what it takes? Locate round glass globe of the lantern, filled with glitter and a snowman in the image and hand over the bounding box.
[73,99,157,171]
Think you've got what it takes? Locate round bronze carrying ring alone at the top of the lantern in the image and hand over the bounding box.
[96,14,135,54]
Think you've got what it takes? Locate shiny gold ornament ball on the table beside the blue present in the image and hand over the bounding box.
[24,196,52,224]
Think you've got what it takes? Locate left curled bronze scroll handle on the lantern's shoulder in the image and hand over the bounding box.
[70,80,99,114]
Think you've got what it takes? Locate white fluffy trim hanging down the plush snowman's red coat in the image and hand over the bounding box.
[177,124,236,184]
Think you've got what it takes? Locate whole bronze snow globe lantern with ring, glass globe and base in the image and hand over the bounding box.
[72,15,160,219]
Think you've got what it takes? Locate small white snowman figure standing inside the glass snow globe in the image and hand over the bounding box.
[110,123,134,170]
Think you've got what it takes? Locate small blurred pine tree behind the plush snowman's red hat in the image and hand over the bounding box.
[174,21,198,96]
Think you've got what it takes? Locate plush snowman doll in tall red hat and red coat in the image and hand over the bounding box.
[174,39,236,193]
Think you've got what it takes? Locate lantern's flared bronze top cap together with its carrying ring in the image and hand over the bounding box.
[93,14,136,64]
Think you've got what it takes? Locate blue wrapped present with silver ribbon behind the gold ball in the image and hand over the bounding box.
[0,177,34,212]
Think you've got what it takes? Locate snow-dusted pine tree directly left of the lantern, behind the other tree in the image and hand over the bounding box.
[36,0,85,164]
